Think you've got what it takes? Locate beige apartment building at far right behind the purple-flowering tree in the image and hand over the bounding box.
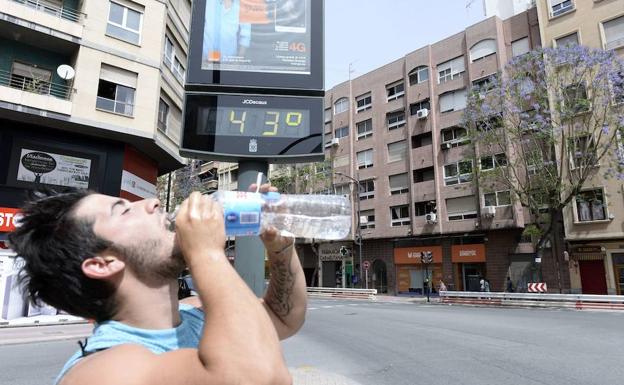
[536,0,624,295]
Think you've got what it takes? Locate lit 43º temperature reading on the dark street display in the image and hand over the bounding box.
[217,108,310,138]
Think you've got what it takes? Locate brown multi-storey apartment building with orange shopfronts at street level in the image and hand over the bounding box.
[319,8,548,293]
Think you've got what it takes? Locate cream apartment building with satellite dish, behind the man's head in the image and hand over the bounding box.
[0,0,191,240]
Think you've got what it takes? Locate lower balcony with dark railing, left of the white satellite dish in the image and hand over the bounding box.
[0,70,73,115]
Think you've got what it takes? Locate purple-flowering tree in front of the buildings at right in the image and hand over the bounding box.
[464,46,624,289]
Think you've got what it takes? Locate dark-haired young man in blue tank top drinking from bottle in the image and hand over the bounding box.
[9,185,306,385]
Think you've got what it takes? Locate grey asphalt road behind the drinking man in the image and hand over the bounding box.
[0,299,624,385]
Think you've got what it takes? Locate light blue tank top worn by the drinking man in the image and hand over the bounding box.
[55,304,204,384]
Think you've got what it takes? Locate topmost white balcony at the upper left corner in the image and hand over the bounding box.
[0,0,85,40]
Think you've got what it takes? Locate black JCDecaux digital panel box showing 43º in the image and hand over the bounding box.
[180,92,324,162]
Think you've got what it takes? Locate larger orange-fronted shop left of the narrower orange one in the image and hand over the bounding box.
[394,246,442,294]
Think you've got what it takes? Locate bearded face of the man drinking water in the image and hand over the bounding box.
[75,194,184,282]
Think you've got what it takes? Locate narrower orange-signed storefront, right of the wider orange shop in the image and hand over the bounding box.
[451,244,487,291]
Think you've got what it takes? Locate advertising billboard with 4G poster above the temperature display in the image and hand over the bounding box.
[187,0,323,91]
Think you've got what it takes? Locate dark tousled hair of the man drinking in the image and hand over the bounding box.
[9,189,115,321]
